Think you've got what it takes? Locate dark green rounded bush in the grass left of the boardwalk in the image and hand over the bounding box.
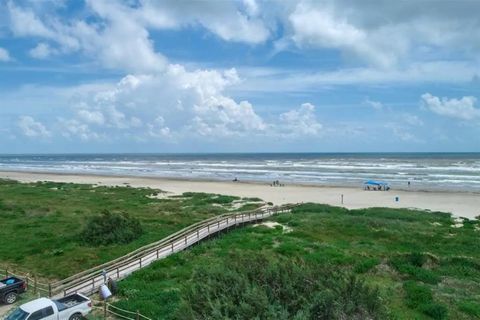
[80,210,143,246]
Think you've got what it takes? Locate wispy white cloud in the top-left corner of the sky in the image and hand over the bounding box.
[8,1,166,72]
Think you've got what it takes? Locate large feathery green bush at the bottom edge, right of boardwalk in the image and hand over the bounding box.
[176,255,384,319]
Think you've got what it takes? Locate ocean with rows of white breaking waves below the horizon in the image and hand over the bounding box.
[0,153,480,192]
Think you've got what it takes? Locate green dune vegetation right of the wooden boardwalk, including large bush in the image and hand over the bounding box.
[117,204,480,319]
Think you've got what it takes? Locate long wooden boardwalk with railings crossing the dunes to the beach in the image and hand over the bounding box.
[49,205,293,296]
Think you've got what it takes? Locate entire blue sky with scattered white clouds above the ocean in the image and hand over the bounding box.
[0,0,480,154]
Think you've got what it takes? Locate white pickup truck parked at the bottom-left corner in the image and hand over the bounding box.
[5,293,92,320]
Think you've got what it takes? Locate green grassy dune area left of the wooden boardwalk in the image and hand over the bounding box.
[0,180,259,279]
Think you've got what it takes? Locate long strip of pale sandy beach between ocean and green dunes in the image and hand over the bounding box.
[0,172,480,219]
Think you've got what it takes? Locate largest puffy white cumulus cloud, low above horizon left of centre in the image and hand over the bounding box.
[55,65,266,140]
